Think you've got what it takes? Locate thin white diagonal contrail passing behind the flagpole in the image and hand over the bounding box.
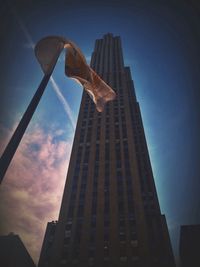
[11,6,76,130]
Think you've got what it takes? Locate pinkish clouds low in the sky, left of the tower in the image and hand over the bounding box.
[0,125,72,262]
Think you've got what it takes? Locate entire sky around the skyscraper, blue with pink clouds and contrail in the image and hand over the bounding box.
[0,0,200,263]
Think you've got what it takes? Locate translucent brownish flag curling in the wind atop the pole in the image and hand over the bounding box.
[35,36,116,112]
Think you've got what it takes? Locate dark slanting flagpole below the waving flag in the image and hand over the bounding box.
[0,70,53,184]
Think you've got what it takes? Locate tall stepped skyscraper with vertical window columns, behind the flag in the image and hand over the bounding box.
[45,33,175,267]
